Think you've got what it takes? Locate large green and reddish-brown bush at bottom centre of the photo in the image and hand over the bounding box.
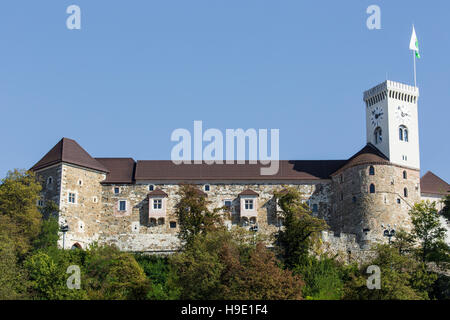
[170,230,303,300]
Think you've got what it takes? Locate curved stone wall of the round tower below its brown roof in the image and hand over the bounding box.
[330,164,420,245]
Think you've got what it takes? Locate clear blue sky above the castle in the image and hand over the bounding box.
[0,0,450,181]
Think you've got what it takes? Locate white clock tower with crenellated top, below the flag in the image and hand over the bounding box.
[364,80,420,169]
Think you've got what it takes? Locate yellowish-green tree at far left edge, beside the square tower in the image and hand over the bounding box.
[0,170,42,256]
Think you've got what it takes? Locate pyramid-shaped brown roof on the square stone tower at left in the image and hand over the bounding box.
[30,138,108,172]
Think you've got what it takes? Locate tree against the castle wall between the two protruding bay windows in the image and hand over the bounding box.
[175,185,223,244]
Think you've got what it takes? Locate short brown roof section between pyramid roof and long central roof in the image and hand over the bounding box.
[95,158,136,184]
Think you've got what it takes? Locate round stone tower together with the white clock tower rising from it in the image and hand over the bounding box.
[330,81,420,246]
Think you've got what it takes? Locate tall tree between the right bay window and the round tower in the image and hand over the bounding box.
[275,188,328,269]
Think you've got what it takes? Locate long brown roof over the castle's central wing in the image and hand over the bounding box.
[135,160,346,182]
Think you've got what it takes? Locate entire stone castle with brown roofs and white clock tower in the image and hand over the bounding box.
[31,81,450,253]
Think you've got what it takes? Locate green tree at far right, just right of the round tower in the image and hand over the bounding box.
[409,201,449,262]
